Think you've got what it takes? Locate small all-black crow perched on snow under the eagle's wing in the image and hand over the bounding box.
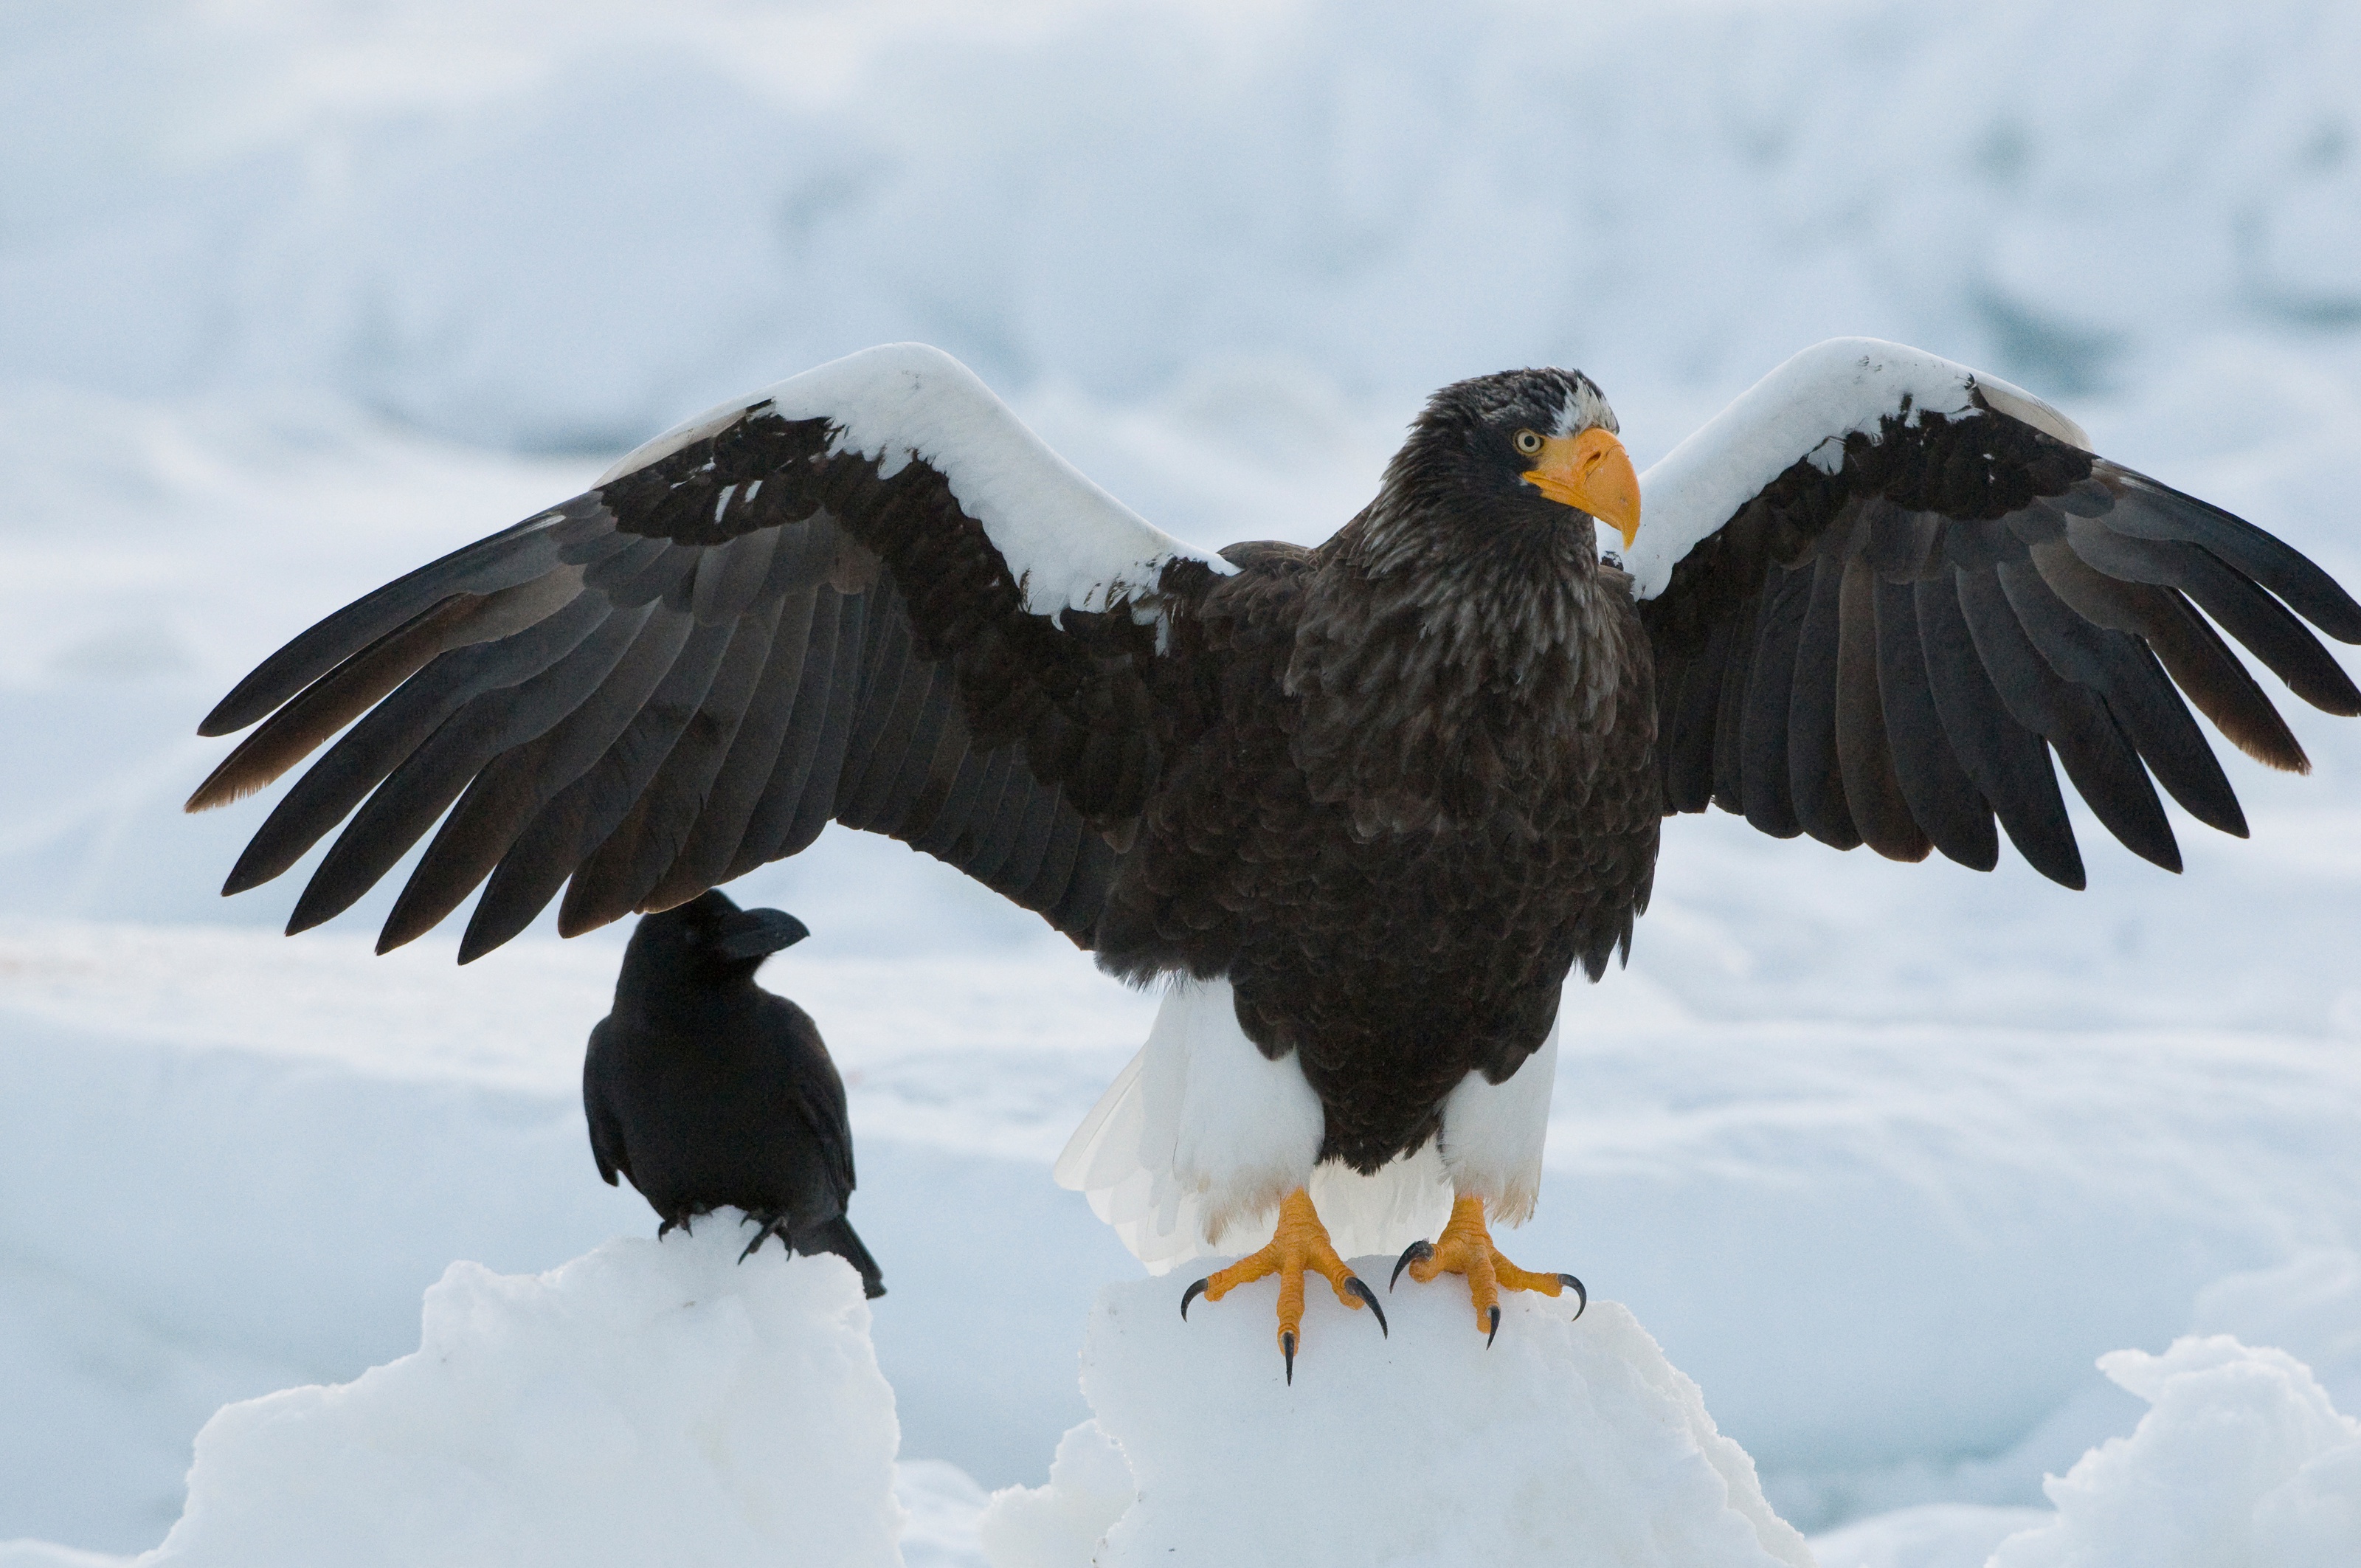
[583,893,885,1296]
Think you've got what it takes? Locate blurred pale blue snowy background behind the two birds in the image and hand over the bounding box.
[0,0,2361,1568]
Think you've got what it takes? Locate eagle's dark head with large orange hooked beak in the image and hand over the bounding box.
[1386,368,1639,545]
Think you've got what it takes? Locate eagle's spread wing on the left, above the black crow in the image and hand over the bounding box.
[189,345,1232,961]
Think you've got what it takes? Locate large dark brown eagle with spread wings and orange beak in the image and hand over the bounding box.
[189,338,2361,1377]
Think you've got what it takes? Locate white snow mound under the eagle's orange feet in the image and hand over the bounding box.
[980,1284,1811,1568]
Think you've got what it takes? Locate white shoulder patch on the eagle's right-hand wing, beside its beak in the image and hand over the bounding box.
[1634,338,2089,600]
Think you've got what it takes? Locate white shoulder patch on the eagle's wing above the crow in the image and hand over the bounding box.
[600,342,1237,616]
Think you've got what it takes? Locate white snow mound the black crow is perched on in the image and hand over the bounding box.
[139,1223,902,1568]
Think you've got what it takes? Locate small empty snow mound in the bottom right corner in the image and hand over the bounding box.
[1991,1334,2361,1568]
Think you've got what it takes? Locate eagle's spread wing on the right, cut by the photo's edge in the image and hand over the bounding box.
[1615,338,2361,888]
